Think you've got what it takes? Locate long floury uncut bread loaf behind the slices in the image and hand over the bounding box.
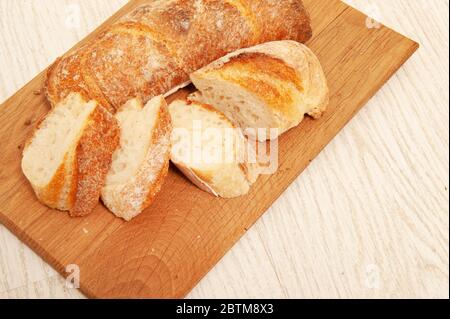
[46,0,311,112]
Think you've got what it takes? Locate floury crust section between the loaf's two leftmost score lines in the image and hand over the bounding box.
[87,28,187,109]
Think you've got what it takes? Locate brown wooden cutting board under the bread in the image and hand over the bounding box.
[0,0,418,298]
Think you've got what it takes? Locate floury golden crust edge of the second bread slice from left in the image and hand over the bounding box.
[102,99,172,221]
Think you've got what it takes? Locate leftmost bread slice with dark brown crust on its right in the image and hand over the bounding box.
[22,93,119,216]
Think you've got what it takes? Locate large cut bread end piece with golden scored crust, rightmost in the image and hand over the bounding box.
[190,40,329,141]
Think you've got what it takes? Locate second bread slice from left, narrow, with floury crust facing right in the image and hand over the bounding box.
[102,96,172,221]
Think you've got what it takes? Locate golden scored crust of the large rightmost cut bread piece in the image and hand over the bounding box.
[192,41,328,117]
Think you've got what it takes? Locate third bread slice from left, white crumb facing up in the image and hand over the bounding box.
[169,100,259,198]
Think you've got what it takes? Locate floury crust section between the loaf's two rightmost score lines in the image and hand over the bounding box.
[123,0,252,74]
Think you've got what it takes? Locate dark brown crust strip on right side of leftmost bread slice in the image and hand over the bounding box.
[70,105,120,217]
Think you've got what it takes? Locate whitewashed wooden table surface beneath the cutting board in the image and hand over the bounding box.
[0,0,449,298]
